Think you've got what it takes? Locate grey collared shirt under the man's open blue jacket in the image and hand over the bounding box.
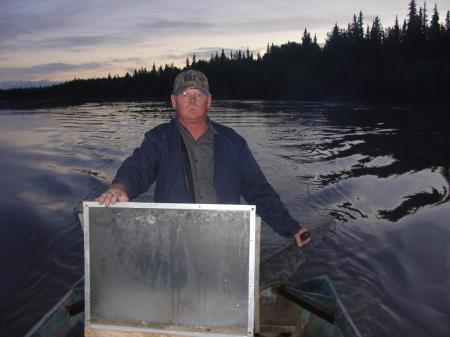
[177,119,217,204]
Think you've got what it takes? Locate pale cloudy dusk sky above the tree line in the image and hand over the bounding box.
[0,0,450,88]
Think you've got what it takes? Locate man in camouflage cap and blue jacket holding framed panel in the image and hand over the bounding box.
[96,70,310,246]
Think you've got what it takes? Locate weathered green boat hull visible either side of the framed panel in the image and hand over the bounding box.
[25,276,361,337]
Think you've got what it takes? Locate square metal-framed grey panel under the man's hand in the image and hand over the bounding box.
[84,202,256,336]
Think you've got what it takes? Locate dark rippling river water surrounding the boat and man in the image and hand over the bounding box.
[0,101,450,337]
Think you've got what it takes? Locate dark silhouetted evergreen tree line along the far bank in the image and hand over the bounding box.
[0,0,450,103]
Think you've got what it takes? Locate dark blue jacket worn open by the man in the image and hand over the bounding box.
[113,119,301,236]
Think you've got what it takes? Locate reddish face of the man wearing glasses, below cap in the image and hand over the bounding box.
[170,88,211,125]
